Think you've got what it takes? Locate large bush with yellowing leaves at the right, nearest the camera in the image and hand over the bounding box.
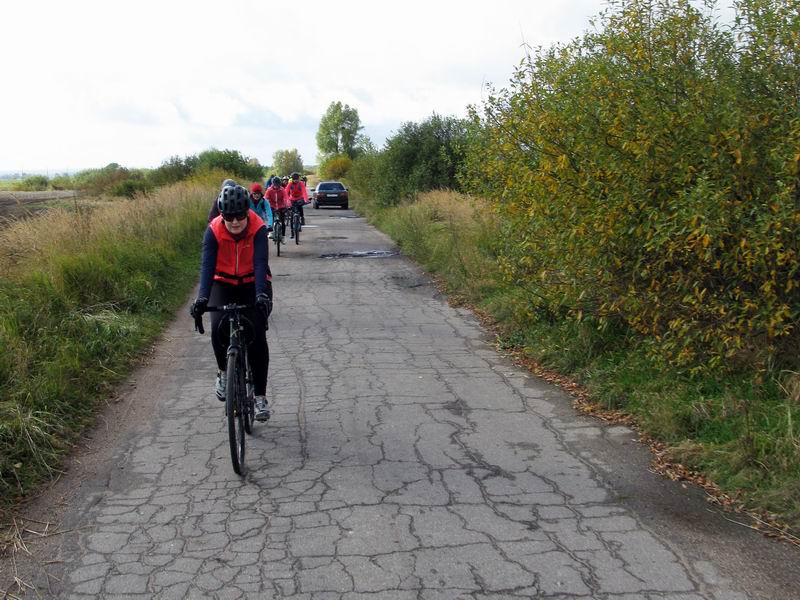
[462,0,800,372]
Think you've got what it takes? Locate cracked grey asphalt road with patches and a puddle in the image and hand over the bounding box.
[0,211,800,600]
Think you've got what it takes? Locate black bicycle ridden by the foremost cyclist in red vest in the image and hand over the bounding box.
[194,304,256,475]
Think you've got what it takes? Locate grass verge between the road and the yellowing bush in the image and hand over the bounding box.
[353,191,800,529]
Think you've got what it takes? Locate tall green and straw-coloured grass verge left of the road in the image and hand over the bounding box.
[0,176,219,507]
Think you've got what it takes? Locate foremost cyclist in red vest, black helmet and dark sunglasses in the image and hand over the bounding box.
[190,185,272,421]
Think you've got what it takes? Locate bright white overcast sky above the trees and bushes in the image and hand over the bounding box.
[0,0,736,173]
